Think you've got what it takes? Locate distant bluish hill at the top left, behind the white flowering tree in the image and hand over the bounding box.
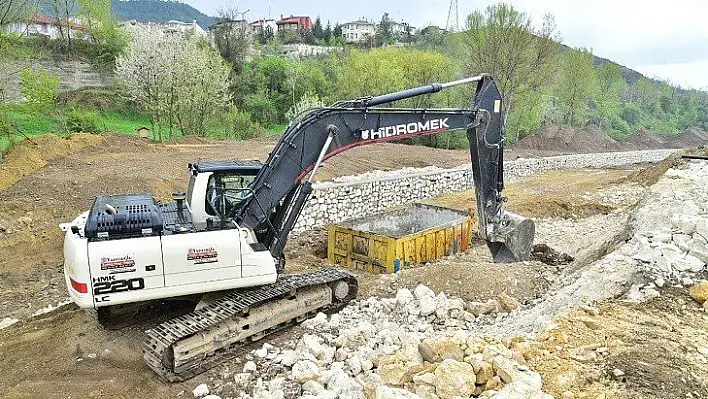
[112,0,216,29]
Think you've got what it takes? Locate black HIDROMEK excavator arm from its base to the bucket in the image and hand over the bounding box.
[234,75,534,265]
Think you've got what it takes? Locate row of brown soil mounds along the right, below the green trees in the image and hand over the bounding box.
[511,126,708,155]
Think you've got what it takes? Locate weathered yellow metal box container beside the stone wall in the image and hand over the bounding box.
[327,204,472,273]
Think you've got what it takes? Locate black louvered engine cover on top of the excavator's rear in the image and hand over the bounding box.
[84,194,164,240]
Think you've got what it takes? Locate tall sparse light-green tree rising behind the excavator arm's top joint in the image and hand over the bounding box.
[464,3,560,140]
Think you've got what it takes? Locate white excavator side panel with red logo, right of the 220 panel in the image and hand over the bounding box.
[162,229,242,287]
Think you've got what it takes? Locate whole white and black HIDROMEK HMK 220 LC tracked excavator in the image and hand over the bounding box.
[60,74,535,381]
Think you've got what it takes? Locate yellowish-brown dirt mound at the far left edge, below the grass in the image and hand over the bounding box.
[0,133,102,190]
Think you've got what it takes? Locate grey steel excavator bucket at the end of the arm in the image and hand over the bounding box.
[487,211,536,263]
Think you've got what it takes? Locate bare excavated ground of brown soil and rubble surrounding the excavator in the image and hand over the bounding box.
[0,136,708,399]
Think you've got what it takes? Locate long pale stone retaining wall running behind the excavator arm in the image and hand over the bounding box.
[294,150,677,232]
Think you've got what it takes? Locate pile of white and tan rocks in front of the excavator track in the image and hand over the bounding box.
[195,285,550,399]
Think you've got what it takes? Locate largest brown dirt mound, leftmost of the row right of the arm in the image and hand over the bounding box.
[513,126,622,153]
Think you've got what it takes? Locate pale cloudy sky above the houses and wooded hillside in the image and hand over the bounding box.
[183,0,708,89]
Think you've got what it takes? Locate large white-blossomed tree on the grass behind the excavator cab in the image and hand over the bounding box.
[116,32,230,139]
